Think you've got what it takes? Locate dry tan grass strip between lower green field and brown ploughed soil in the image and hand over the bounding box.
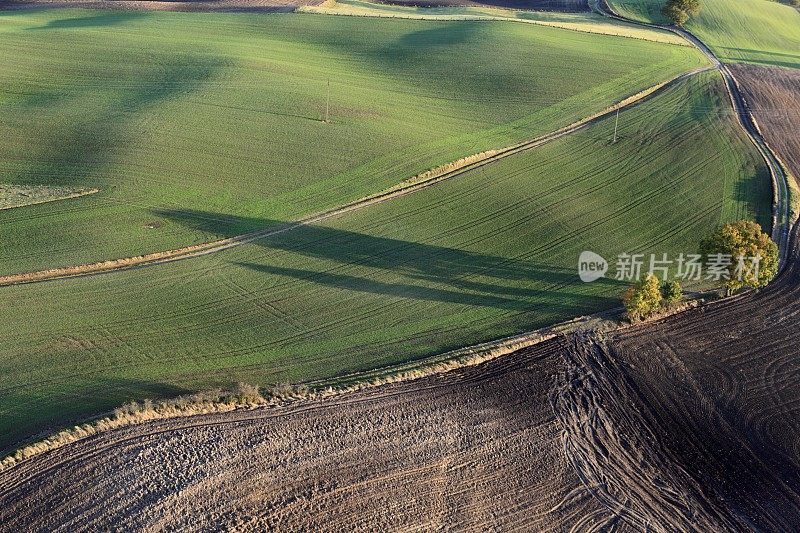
[0,288,713,476]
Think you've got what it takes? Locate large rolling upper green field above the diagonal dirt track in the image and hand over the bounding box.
[0,10,705,274]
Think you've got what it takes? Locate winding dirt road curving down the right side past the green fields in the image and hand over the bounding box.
[590,0,800,272]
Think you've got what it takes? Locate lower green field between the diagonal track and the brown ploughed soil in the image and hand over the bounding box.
[0,68,771,447]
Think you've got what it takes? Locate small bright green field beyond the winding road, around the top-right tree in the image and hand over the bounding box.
[609,0,800,68]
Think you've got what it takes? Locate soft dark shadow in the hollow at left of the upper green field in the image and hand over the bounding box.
[6,53,227,190]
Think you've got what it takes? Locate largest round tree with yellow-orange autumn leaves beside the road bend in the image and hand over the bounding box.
[700,220,778,292]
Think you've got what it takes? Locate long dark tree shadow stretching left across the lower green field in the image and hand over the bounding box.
[157,206,625,312]
